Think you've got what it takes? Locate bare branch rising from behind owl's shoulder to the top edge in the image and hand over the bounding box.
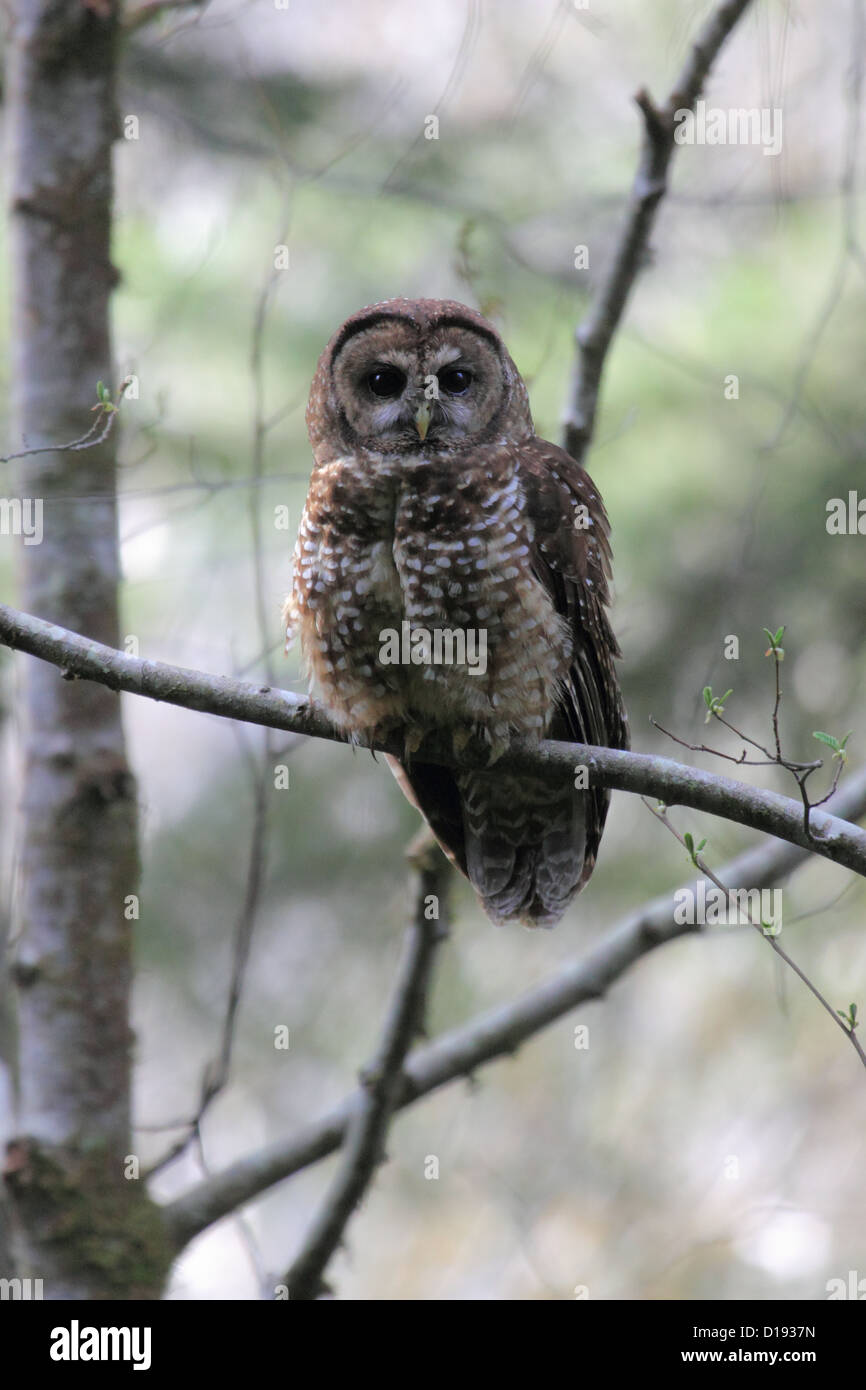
[563,0,749,463]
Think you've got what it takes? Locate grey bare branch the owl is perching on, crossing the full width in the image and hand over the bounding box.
[0,603,866,876]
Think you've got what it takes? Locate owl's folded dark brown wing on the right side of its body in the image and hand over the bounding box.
[518,438,628,887]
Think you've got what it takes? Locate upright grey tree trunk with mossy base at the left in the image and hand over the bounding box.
[6,0,167,1298]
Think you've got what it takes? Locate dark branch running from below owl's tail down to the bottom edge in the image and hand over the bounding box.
[285,835,450,1300]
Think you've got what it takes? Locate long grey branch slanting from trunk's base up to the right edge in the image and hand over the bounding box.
[164,769,866,1251]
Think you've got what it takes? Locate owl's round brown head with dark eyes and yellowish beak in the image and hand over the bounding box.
[307,299,532,461]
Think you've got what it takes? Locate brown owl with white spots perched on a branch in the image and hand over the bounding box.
[284,299,628,927]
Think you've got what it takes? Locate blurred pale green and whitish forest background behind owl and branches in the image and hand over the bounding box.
[0,0,866,1300]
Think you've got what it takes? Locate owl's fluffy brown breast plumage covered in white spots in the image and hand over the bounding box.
[295,460,570,739]
